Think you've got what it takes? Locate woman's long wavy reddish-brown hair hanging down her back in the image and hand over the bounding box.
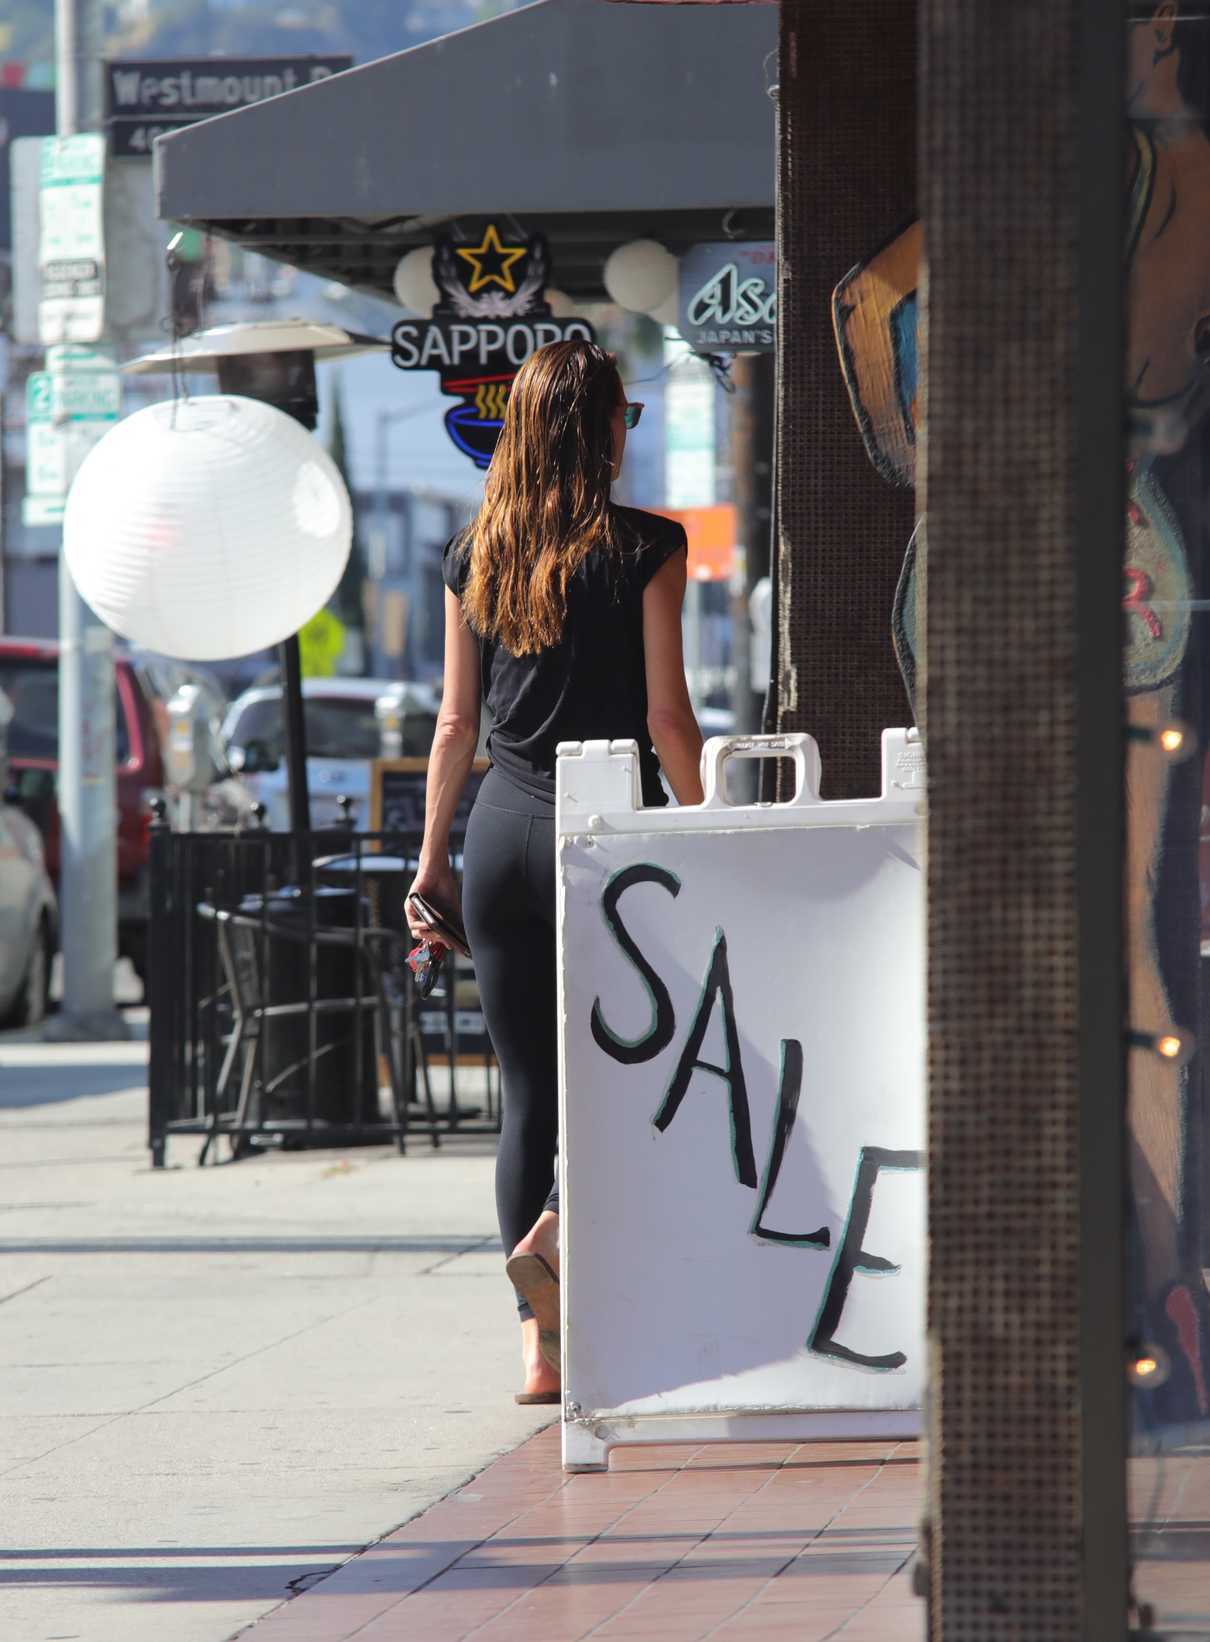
[463,342,622,655]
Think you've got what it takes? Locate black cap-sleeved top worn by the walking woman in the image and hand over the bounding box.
[442,507,686,805]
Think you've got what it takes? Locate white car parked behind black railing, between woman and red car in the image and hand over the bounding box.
[222,678,440,832]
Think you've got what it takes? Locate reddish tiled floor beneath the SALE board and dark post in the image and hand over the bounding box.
[246,1425,1210,1642]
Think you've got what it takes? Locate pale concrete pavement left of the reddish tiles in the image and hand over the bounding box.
[0,1016,552,1642]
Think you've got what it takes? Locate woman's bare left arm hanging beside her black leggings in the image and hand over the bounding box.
[412,588,481,905]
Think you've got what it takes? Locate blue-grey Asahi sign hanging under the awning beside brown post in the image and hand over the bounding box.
[680,241,777,353]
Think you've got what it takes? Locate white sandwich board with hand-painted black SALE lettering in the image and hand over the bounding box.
[558,731,924,1470]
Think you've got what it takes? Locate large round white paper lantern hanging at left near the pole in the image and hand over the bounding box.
[62,394,353,662]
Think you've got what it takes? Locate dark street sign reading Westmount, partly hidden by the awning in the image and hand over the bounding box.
[105,56,353,158]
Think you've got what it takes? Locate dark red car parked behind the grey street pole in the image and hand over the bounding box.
[0,639,164,977]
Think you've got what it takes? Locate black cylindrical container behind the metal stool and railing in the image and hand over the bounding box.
[233,887,379,1140]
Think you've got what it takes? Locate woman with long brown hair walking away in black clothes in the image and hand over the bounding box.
[407,342,701,1402]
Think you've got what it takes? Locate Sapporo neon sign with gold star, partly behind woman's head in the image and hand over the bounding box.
[391,223,594,468]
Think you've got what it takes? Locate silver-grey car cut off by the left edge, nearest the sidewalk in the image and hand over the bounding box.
[0,691,59,1026]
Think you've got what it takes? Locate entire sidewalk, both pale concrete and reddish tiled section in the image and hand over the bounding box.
[0,1036,1210,1642]
